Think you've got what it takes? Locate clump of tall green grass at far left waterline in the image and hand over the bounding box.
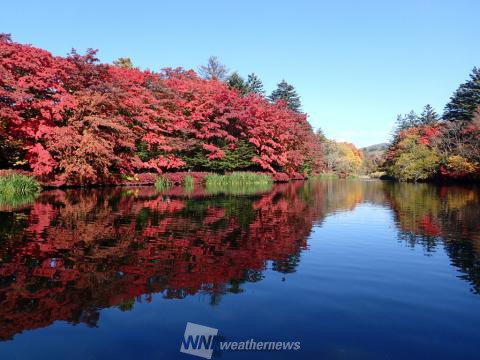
[0,174,41,207]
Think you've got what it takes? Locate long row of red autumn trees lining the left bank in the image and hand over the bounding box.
[0,36,321,185]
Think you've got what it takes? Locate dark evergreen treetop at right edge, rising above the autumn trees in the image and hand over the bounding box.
[443,67,480,121]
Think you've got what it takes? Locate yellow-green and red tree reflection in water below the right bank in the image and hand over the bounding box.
[384,184,480,294]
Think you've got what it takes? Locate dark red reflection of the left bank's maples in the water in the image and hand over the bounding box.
[0,184,319,339]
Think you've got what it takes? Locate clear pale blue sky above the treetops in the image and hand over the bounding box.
[0,0,480,146]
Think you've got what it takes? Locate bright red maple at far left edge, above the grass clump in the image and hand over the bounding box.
[0,35,75,176]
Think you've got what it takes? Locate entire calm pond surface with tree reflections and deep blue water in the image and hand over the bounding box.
[0,181,480,359]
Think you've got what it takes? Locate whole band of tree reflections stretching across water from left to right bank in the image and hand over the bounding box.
[0,181,480,339]
